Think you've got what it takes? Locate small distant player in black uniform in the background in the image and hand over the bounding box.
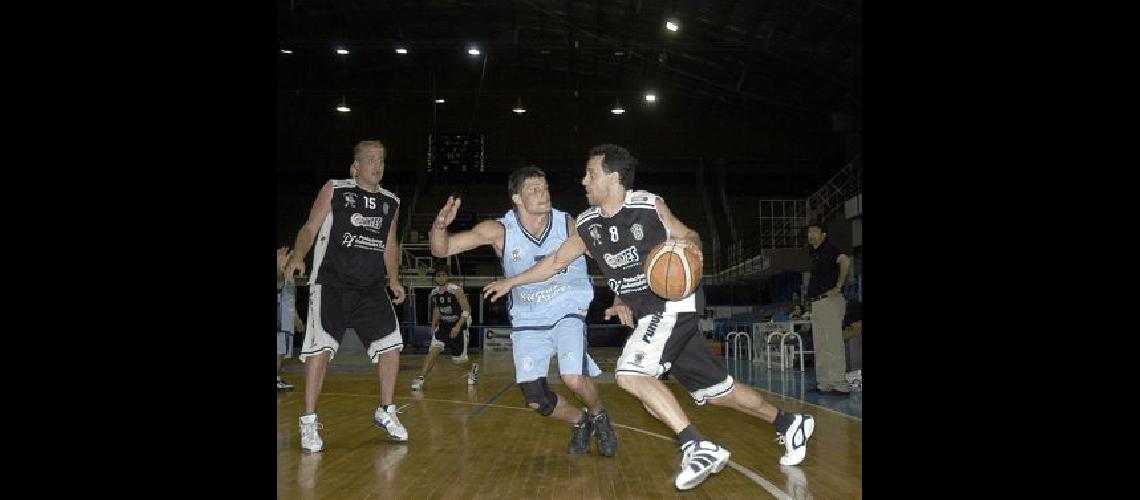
[412,268,479,391]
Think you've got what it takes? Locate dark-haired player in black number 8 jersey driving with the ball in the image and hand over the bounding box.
[483,145,815,490]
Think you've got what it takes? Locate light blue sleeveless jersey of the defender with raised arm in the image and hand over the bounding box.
[498,208,594,331]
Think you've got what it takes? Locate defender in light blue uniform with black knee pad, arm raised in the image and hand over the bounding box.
[429,166,618,457]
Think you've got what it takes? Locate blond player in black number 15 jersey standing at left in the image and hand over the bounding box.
[285,140,408,452]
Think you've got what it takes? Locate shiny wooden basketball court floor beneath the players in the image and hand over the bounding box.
[277,347,863,499]
